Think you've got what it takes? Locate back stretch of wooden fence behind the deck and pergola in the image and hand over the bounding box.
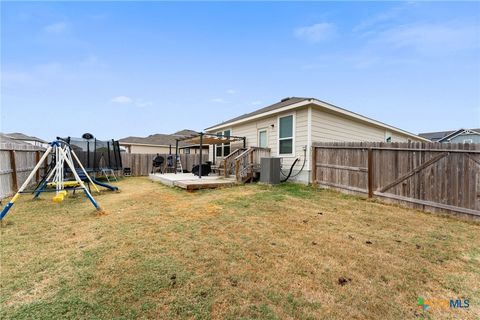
[121,153,208,176]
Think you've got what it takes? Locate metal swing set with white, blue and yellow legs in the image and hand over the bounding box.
[0,137,102,221]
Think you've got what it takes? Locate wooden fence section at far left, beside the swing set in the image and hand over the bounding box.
[0,144,46,199]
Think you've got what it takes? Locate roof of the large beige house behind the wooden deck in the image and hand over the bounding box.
[205,97,426,140]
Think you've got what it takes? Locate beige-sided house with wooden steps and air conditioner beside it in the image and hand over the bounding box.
[205,97,428,183]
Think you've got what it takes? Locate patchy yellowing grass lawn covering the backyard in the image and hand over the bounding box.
[0,178,480,319]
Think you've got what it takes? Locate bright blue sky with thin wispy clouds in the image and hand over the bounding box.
[0,2,480,140]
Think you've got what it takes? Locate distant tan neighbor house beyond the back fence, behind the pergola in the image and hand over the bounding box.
[119,129,208,154]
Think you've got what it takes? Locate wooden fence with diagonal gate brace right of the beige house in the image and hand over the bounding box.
[312,142,480,217]
